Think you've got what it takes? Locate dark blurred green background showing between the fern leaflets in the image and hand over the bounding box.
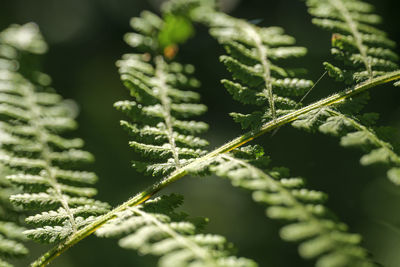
[0,0,400,267]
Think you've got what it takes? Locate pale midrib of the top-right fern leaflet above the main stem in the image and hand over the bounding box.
[330,0,373,79]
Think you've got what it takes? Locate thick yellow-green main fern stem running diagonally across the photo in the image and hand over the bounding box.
[31,71,400,267]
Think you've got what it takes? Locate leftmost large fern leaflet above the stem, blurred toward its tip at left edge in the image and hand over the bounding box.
[0,24,109,243]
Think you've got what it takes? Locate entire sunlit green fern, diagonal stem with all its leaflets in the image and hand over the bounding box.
[0,0,400,267]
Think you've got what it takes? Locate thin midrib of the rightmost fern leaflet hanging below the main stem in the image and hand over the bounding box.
[325,108,400,164]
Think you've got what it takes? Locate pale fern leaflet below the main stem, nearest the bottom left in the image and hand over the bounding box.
[96,194,257,267]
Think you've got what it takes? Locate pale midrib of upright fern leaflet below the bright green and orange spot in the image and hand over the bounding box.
[155,56,181,169]
